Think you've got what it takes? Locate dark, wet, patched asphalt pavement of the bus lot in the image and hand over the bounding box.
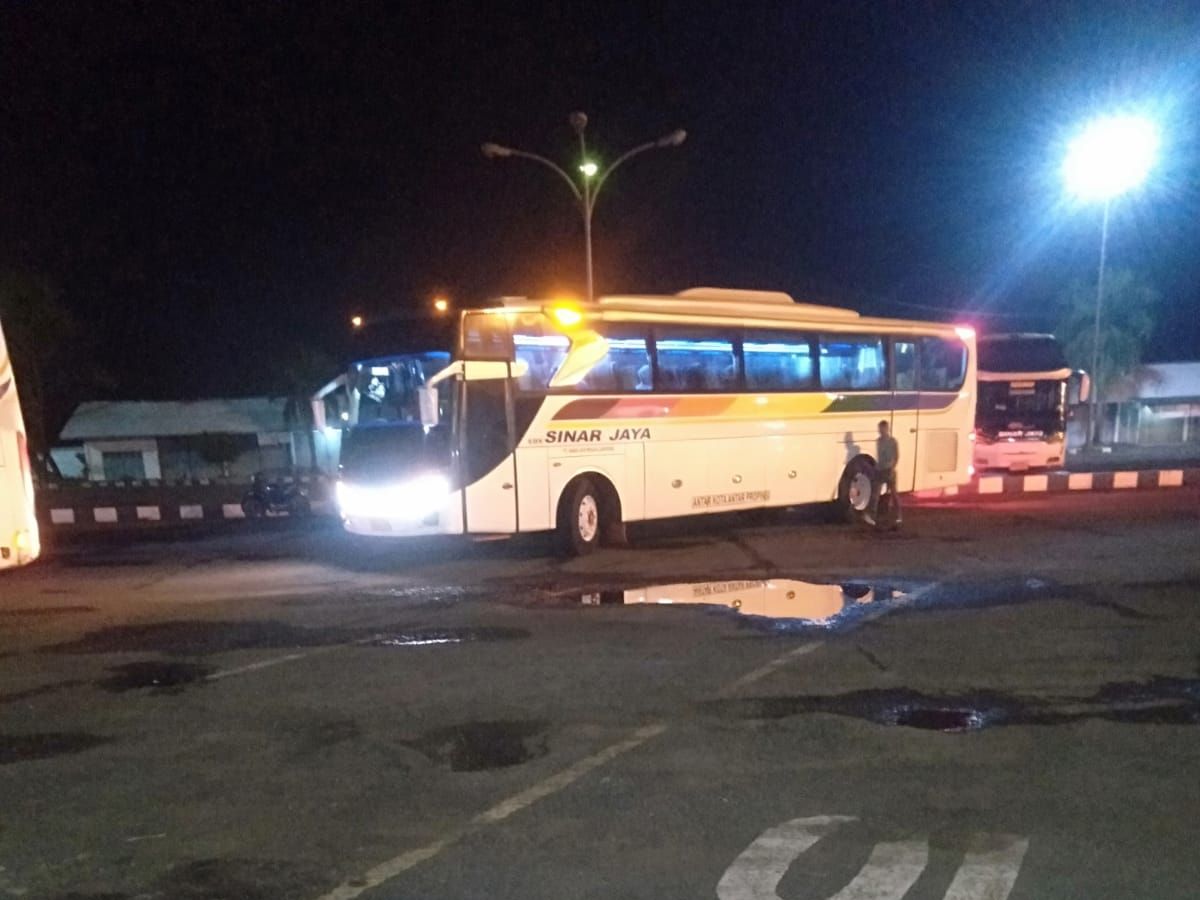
[0,488,1200,900]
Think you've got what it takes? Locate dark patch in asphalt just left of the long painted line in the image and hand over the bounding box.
[406,721,548,772]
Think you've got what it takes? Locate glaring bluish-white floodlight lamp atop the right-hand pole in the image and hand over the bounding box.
[1062,115,1158,200]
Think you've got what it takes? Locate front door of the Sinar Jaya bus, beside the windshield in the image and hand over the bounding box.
[458,360,517,534]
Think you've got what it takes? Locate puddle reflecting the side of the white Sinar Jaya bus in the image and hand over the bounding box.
[548,577,1066,632]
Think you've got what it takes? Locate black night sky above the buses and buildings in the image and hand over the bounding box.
[0,0,1200,398]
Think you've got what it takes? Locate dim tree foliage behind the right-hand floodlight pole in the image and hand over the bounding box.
[1055,269,1159,397]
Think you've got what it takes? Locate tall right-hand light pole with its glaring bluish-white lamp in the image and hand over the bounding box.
[1062,115,1159,445]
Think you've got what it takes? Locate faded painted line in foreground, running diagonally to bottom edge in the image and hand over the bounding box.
[319,724,667,900]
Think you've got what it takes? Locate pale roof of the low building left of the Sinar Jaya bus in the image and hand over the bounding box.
[59,397,288,440]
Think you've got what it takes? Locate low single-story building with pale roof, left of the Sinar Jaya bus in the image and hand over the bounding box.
[52,397,336,481]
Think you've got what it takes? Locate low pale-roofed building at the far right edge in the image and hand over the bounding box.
[1100,362,1200,446]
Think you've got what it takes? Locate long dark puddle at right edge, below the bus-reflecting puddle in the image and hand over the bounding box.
[704,677,1200,733]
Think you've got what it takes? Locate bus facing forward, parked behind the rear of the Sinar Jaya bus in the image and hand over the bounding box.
[974,334,1090,472]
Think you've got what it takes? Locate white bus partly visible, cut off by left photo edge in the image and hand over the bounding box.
[0,316,41,569]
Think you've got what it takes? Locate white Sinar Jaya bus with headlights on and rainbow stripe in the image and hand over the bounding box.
[338,288,976,553]
